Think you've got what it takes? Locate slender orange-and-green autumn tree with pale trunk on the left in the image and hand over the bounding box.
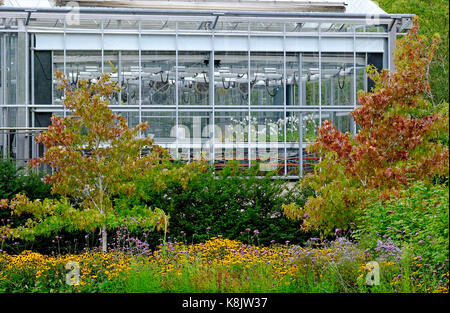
[0,72,205,251]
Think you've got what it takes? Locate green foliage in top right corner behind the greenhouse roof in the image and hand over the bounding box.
[376,0,449,106]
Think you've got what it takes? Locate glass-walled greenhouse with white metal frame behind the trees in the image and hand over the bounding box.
[0,0,412,179]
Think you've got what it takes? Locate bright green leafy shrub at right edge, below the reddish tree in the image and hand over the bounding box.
[354,182,449,274]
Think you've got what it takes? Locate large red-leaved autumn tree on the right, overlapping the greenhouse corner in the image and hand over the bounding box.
[284,20,449,233]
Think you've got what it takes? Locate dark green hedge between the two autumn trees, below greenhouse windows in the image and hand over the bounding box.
[117,162,309,244]
